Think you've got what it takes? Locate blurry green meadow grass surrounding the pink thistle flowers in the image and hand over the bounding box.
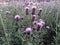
[0,3,60,45]
